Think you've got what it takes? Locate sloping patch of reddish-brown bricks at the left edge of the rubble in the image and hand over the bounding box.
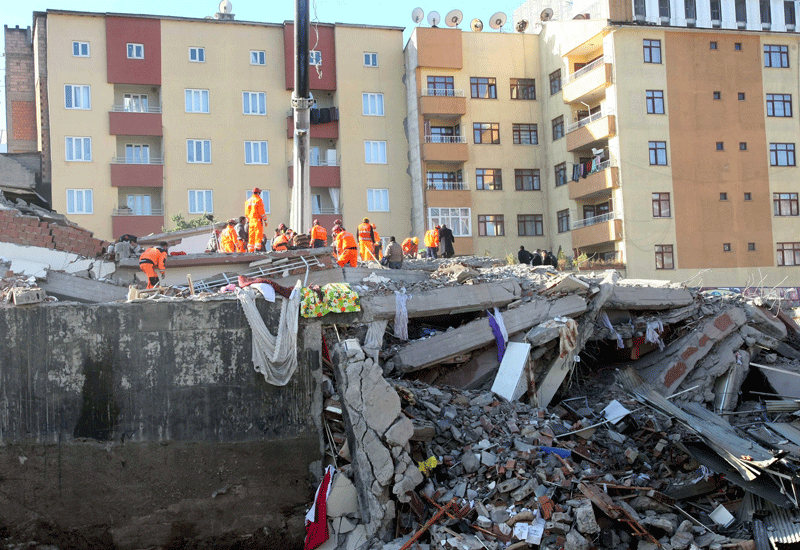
[0,210,111,258]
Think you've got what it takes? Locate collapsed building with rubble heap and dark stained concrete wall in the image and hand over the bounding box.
[0,203,800,550]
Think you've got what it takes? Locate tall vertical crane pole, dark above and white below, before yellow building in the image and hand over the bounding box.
[289,0,312,233]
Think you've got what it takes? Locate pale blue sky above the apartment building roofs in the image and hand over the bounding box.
[0,0,524,142]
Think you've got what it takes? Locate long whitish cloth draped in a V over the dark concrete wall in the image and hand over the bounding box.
[236,281,302,386]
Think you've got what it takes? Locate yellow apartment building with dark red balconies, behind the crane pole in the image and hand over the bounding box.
[6,10,410,243]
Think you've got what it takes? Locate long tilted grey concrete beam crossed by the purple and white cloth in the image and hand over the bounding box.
[394,295,586,373]
